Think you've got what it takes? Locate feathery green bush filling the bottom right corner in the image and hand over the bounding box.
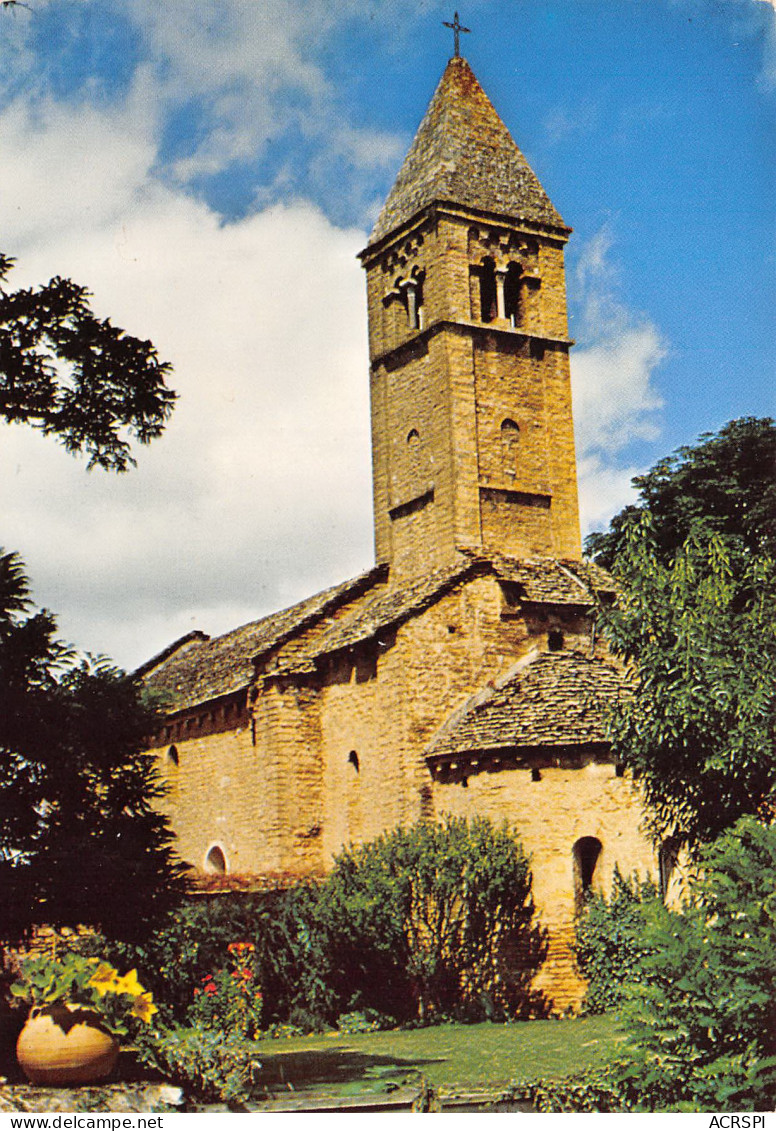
[621,818,776,1111]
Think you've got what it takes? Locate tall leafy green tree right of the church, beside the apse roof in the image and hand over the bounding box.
[598,421,776,851]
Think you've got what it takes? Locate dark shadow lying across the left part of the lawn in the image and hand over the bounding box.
[259,1045,443,1091]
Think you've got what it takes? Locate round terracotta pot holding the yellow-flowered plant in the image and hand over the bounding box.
[16,1005,119,1083]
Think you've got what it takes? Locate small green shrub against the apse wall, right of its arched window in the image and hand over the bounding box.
[576,866,659,1013]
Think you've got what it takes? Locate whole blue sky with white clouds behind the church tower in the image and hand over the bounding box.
[0,0,776,665]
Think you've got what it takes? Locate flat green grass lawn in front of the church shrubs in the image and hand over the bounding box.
[257,1017,622,1095]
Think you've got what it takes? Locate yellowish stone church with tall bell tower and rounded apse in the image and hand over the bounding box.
[141,52,658,1011]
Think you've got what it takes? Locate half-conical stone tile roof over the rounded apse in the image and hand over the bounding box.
[425,651,623,761]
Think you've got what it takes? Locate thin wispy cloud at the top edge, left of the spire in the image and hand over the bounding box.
[119,0,402,195]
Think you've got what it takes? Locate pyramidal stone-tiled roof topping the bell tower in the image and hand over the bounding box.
[369,58,567,245]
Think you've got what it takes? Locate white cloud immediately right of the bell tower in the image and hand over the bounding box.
[571,225,667,533]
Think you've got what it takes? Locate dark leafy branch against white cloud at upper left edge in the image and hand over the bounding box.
[0,253,175,472]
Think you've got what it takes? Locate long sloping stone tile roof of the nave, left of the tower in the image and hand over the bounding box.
[140,567,386,711]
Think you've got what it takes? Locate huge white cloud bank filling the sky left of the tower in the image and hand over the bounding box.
[0,92,372,664]
